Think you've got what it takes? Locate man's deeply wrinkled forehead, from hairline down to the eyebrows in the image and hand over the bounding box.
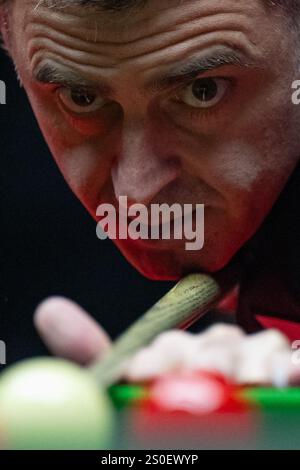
[13,0,284,85]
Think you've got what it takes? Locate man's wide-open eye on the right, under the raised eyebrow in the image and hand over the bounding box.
[176,77,230,109]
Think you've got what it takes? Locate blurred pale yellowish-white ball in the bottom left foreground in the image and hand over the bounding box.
[0,358,114,450]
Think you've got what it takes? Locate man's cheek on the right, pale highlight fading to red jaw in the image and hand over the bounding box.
[200,135,297,246]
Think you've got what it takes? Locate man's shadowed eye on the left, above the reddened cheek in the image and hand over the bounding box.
[57,87,106,115]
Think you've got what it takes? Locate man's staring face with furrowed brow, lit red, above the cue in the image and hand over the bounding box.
[5,0,300,279]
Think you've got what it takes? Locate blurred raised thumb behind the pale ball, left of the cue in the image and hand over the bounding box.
[34,297,110,365]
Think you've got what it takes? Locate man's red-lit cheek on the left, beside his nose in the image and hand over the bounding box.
[24,91,117,208]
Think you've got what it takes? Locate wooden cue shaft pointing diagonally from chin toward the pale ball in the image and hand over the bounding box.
[89,274,221,386]
